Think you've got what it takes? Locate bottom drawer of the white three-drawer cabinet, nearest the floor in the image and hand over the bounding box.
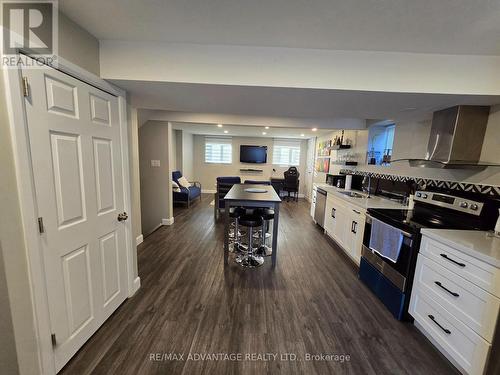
[410,288,490,375]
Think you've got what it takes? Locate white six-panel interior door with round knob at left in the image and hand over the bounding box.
[23,59,127,371]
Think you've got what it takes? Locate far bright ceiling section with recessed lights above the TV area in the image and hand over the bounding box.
[172,122,331,139]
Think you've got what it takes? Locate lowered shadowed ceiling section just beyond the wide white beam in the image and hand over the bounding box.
[116,80,500,124]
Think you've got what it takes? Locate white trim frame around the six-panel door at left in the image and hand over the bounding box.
[3,50,140,374]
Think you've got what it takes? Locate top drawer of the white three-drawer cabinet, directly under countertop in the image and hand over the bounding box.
[420,236,500,297]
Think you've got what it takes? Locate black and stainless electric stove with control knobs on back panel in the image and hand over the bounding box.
[359,190,500,320]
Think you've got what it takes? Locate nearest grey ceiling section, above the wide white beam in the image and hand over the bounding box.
[59,0,500,55]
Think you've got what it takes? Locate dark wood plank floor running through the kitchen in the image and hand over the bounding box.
[61,195,456,375]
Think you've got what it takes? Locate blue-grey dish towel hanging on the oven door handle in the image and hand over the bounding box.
[370,218,403,263]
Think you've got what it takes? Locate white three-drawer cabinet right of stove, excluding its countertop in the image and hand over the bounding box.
[410,235,500,375]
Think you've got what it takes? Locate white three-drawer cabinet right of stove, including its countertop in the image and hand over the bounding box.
[410,229,500,375]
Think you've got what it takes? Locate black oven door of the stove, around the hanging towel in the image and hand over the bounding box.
[361,215,416,292]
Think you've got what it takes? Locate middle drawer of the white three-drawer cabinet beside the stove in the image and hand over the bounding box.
[415,254,500,342]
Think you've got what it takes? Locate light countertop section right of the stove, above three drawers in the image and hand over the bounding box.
[422,229,500,268]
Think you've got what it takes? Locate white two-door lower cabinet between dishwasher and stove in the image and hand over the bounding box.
[325,197,365,265]
